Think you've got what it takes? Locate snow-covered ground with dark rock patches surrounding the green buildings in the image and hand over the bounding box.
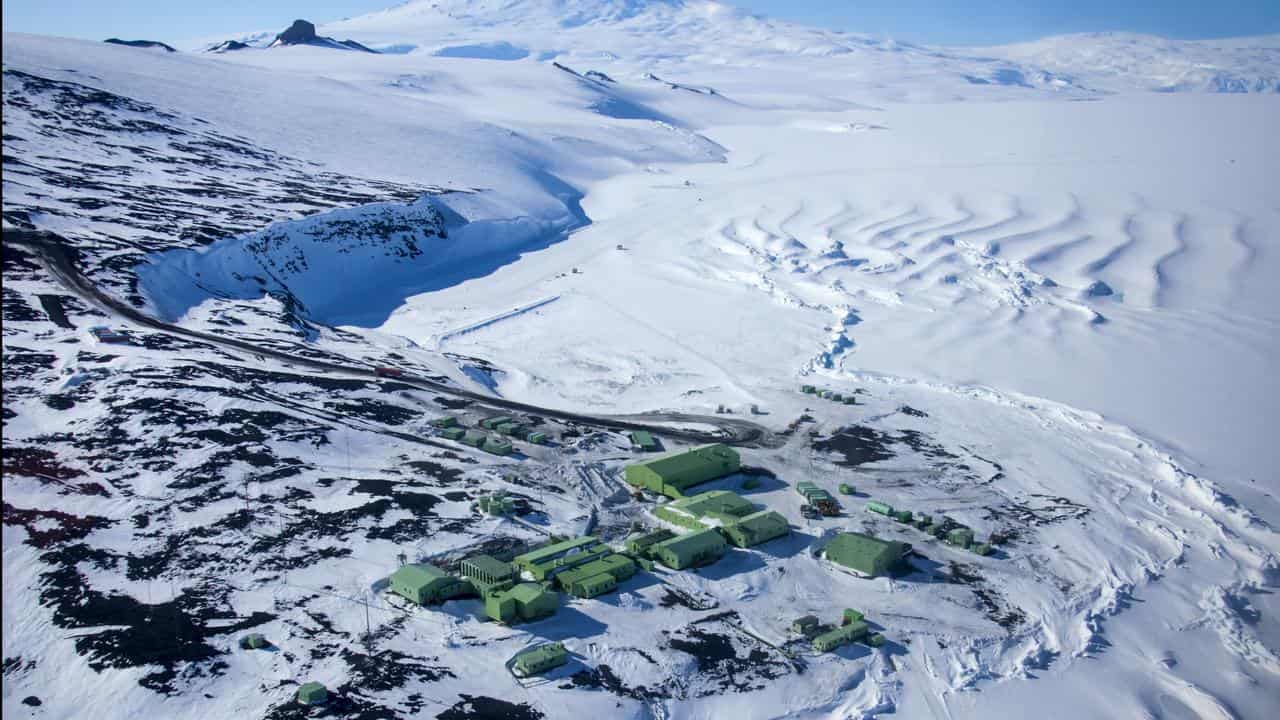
[4,0,1280,719]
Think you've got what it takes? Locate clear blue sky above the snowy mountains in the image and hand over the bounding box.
[4,0,1280,45]
